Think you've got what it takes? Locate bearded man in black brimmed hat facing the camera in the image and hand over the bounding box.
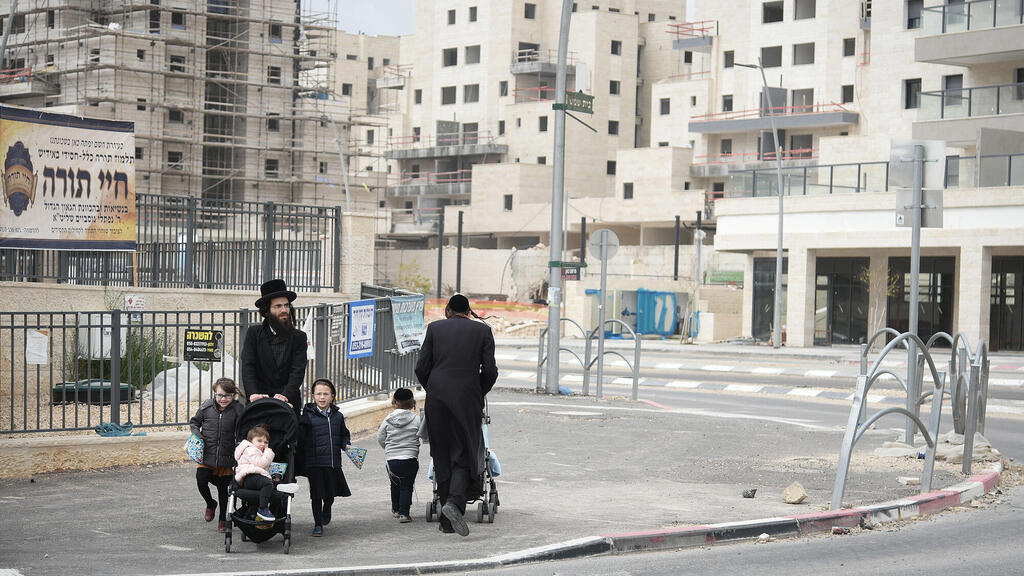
[241,280,306,413]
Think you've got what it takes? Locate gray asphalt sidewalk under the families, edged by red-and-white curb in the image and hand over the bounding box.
[0,387,993,575]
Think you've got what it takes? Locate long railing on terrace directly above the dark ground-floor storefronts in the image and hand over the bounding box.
[726,154,1024,198]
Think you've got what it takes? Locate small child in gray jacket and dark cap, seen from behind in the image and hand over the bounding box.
[377,388,420,524]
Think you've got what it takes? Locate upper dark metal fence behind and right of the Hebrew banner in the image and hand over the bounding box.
[0,194,341,291]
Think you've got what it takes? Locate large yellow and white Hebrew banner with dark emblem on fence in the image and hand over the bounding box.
[0,107,135,250]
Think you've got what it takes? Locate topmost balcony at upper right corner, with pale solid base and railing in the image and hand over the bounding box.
[913,0,1024,66]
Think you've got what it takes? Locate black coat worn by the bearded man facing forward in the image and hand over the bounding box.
[241,320,306,415]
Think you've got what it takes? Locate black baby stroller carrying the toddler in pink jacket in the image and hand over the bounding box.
[224,398,299,554]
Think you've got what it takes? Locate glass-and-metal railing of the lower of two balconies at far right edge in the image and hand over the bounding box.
[918,82,1024,122]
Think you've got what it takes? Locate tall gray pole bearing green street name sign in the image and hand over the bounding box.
[538,0,577,394]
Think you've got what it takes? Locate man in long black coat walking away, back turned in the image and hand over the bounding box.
[416,294,498,536]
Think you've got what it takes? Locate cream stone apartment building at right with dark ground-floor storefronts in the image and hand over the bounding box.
[679,0,1024,351]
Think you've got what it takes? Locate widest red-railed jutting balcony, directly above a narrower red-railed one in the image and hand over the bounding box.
[689,102,860,134]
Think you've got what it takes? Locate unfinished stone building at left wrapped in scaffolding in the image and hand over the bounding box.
[0,0,385,205]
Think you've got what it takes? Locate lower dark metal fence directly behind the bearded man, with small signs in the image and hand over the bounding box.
[0,298,417,434]
